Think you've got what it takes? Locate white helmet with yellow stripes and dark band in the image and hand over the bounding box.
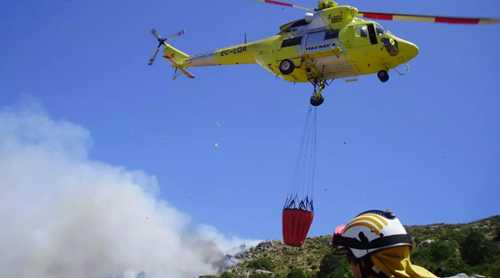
[332,210,412,259]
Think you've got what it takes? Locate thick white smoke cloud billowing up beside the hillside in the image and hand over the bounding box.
[0,99,259,278]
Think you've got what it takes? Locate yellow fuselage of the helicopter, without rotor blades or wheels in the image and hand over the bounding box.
[167,5,418,82]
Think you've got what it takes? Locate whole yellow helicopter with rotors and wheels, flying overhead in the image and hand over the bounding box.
[149,0,500,106]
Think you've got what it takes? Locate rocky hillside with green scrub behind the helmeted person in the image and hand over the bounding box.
[204,215,500,278]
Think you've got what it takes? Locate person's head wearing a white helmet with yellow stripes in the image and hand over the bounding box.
[332,210,412,278]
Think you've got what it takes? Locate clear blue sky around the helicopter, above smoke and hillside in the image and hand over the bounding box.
[0,0,500,245]
